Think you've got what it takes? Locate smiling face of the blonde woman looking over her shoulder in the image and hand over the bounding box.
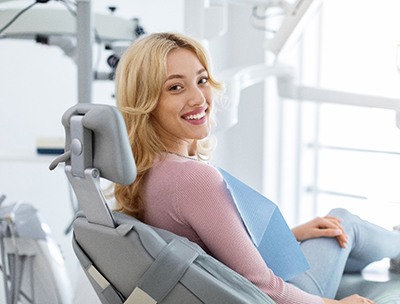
[152,48,212,155]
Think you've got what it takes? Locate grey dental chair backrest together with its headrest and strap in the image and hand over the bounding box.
[51,104,273,304]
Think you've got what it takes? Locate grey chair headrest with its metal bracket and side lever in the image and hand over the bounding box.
[50,104,136,227]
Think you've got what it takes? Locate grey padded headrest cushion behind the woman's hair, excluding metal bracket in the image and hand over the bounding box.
[62,103,136,185]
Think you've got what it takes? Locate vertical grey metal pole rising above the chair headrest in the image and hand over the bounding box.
[76,0,93,103]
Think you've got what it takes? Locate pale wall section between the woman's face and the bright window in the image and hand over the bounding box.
[206,6,265,192]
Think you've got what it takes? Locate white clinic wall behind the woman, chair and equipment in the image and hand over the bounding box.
[0,0,264,300]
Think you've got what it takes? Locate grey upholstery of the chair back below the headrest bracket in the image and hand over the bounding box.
[74,213,273,304]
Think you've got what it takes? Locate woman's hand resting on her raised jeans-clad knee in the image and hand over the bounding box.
[292,215,347,248]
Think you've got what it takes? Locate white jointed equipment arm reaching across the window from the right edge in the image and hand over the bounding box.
[218,63,400,130]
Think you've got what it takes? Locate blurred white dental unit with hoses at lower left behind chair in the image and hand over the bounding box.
[0,196,72,304]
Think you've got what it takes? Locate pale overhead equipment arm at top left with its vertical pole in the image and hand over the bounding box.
[0,0,144,102]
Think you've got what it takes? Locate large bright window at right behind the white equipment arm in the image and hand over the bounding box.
[265,0,400,228]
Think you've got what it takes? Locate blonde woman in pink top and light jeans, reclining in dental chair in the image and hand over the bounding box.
[115,33,400,304]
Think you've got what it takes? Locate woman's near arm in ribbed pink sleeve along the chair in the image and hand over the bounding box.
[175,166,323,304]
